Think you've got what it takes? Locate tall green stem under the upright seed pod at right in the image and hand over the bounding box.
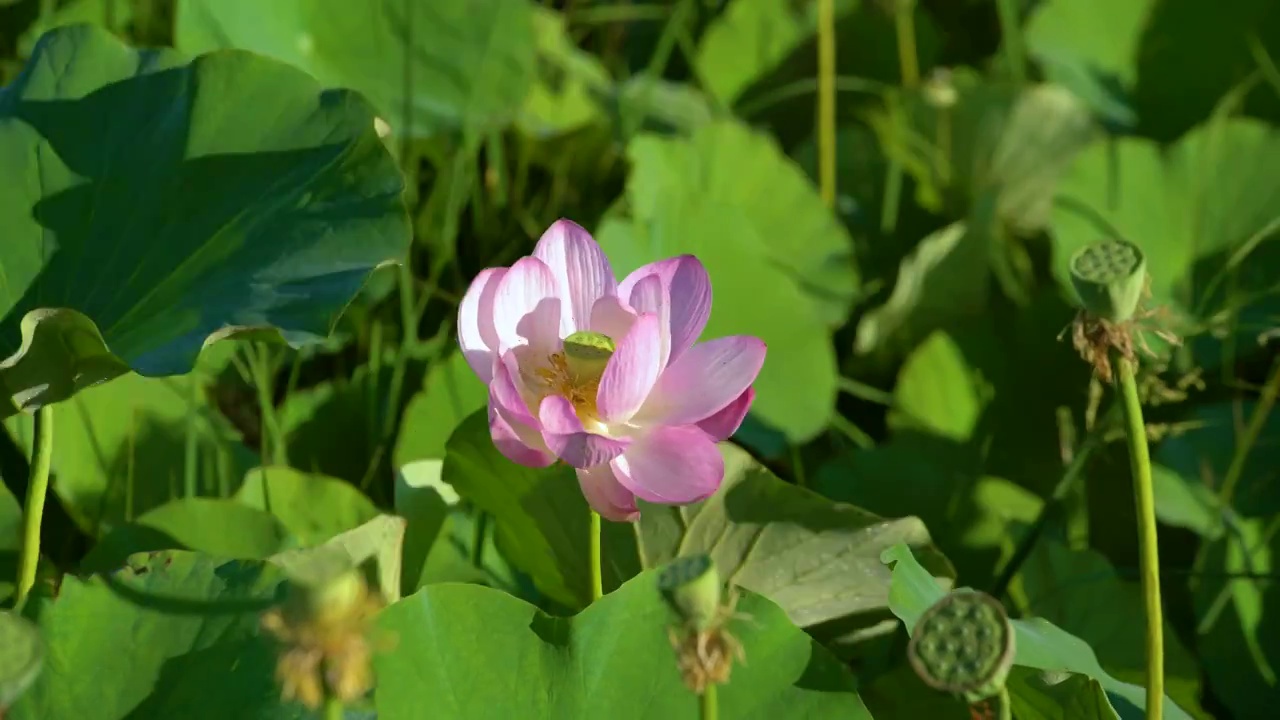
[1115,356,1165,720]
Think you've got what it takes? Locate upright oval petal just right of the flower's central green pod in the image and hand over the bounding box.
[595,313,662,423]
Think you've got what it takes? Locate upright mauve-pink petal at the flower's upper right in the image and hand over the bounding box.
[618,255,712,361]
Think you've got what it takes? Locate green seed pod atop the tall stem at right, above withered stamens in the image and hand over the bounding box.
[1071,240,1147,323]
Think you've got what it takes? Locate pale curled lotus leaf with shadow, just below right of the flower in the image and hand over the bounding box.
[640,443,954,650]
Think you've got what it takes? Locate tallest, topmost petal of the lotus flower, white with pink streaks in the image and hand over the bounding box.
[534,219,618,336]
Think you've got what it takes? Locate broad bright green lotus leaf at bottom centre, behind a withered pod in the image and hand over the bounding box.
[375,570,870,720]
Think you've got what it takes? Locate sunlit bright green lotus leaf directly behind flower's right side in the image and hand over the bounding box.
[599,120,858,441]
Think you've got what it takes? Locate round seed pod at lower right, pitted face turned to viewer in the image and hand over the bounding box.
[906,588,1014,703]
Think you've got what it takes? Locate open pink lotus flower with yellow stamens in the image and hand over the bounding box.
[458,219,765,520]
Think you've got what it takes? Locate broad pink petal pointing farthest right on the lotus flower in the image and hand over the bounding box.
[637,336,767,425]
